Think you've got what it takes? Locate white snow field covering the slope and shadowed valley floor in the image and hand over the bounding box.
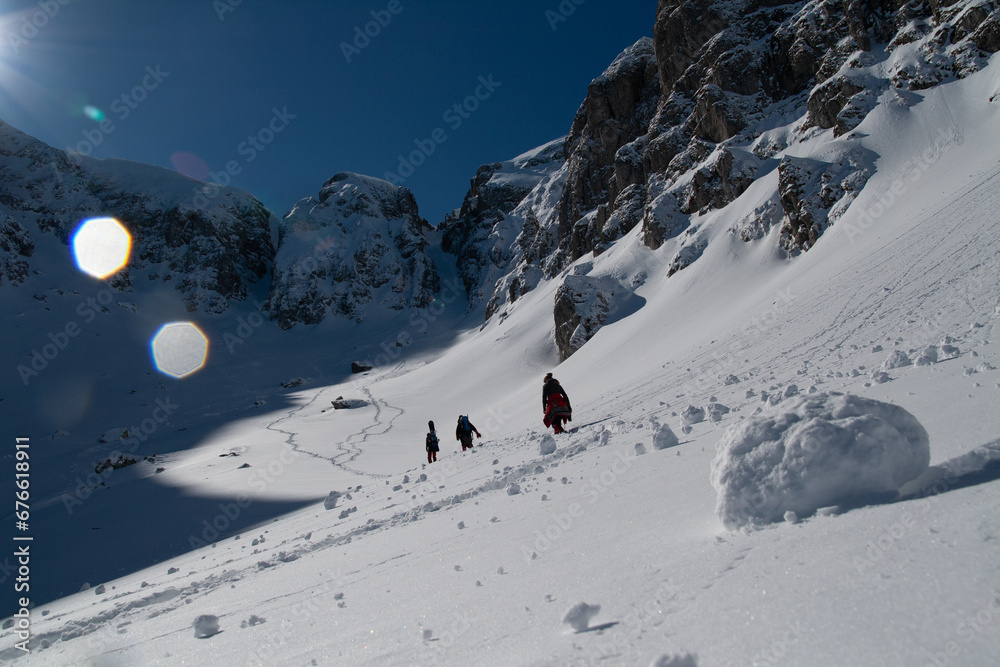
[0,56,1000,667]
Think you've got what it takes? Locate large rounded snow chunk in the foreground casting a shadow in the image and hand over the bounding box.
[711,392,930,530]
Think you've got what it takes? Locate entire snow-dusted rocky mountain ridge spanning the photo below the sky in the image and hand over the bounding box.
[0,0,1000,344]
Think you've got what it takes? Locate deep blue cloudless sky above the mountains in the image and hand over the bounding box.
[0,0,656,224]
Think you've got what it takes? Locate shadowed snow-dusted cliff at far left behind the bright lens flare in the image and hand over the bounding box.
[0,122,274,313]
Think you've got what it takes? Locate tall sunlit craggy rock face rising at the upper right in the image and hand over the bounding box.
[450,0,1000,354]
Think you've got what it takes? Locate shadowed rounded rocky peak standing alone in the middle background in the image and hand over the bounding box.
[269,172,439,329]
